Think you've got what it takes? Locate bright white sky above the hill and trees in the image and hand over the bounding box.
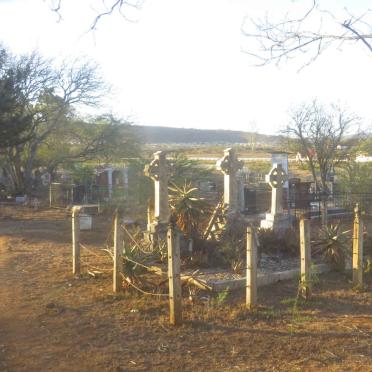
[0,0,372,134]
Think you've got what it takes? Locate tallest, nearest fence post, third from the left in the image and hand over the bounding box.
[167,226,182,325]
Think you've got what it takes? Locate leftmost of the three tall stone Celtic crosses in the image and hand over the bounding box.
[145,151,169,223]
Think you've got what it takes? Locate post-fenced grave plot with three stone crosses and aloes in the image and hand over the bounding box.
[68,149,370,324]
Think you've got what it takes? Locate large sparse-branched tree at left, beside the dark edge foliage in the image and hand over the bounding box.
[0,48,106,192]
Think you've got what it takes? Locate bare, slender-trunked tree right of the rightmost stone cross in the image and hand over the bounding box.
[286,101,357,223]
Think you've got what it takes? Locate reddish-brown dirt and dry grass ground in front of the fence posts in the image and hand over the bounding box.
[0,207,372,371]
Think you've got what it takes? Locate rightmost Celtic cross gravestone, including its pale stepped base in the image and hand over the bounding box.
[261,164,290,231]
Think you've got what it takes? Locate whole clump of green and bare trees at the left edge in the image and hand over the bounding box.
[0,46,138,193]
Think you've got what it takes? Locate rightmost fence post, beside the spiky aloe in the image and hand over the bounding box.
[353,204,363,287]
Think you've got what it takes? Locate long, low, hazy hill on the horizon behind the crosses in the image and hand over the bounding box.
[132,125,280,145]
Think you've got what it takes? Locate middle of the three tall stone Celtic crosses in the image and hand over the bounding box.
[216,148,243,213]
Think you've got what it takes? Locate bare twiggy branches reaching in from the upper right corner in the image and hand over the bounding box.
[242,0,372,67]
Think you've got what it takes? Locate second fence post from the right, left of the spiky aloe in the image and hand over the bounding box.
[300,217,311,299]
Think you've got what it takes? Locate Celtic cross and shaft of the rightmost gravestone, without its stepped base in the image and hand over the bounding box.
[265,163,287,216]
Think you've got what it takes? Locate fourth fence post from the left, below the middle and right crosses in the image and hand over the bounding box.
[245,226,257,309]
